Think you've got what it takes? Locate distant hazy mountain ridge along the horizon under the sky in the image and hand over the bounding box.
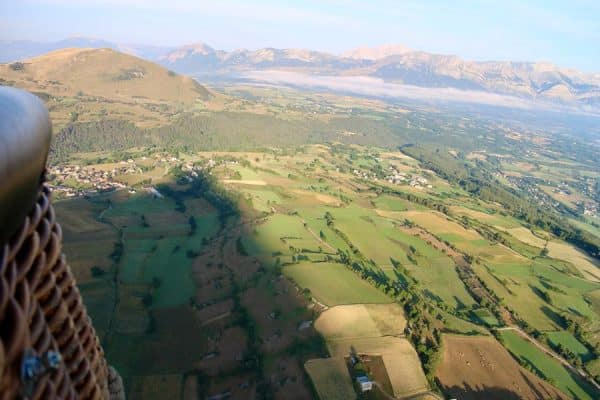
[0,38,600,108]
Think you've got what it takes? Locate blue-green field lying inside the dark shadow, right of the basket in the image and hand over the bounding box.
[104,195,220,307]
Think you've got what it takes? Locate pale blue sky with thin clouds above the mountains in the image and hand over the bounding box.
[0,0,600,72]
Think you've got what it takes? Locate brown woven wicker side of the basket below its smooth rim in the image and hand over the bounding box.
[0,185,110,400]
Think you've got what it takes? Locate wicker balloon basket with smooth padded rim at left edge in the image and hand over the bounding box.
[0,87,125,400]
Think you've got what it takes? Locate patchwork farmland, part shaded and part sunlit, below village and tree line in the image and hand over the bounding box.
[51,145,600,400]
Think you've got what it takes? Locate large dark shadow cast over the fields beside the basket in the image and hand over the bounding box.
[58,175,328,399]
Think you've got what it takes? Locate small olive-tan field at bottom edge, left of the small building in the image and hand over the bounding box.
[304,357,356,400]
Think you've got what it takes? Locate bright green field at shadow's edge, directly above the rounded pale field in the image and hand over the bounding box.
[283,263,391,306]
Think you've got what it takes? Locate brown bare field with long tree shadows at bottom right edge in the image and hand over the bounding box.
[436,335,569,400]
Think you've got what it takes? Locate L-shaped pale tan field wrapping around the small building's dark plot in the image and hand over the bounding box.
[327,336,429,397]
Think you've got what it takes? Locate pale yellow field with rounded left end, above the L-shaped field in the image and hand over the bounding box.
[315,303,406,340]
